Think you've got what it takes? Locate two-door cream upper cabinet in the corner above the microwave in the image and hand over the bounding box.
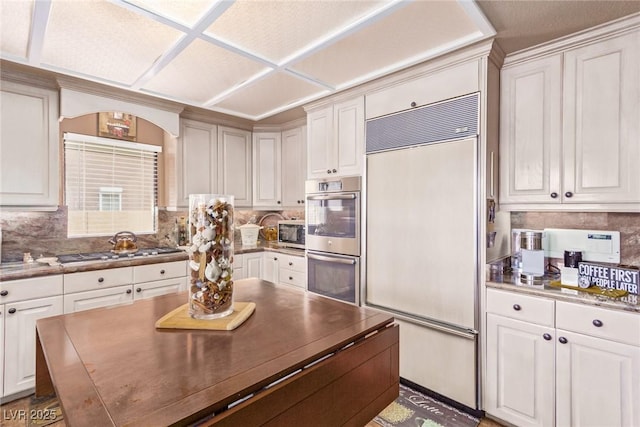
[253,126,306,209]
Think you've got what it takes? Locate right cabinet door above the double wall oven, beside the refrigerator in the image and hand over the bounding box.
[331,97,364,176]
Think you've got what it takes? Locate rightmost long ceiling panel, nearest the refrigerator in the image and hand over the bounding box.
[292,1,482,88]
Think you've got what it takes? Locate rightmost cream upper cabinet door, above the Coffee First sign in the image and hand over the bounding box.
[563,31,640,203]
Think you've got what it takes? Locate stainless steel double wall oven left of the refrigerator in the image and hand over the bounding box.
[305,176,361,305]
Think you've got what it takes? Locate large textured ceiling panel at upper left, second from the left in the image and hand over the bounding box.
[42,1,181,85]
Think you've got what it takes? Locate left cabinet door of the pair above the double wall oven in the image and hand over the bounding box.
[307,107,337,178]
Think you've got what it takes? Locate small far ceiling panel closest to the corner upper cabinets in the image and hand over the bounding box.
[214,72,328,117]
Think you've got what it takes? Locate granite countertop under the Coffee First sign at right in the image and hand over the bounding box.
[486,263,640,313]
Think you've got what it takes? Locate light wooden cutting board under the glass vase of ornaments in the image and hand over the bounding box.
[156,302,256,331]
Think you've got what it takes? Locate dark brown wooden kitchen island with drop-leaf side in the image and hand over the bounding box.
[36,279,399,426]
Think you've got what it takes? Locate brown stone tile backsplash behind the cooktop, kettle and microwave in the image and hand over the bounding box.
[0,206,304,262]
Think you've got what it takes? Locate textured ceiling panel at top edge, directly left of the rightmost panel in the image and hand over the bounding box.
[206,0,388,64]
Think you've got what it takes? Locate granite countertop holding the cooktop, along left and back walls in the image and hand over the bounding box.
[0,242,304,282]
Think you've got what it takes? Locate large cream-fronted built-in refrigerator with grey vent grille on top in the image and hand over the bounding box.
[363,95,479,409]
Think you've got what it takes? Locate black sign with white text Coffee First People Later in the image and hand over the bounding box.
[578,262,640,295]
